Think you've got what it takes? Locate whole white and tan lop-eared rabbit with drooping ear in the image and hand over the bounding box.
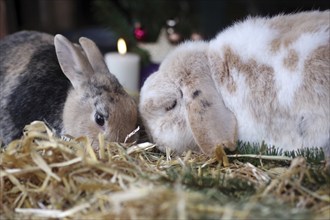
[139,10,330,162]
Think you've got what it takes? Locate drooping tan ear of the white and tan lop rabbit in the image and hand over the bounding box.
[183,74,237,155]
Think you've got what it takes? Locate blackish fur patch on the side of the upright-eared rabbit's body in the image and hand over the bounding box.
[7,45,71,138]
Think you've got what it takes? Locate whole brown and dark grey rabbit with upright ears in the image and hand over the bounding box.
[0,31,137,146]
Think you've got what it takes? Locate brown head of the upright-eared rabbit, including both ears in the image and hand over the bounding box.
[54,35,137,146]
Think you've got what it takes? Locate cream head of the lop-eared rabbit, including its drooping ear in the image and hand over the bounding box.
[139,42,236,155]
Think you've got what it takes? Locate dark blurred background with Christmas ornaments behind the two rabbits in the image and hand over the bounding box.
[0,0,330,86]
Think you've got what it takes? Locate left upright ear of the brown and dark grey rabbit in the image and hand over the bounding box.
[54,34,93,89]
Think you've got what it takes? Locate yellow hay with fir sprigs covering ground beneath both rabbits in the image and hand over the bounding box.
[0,122,330,219]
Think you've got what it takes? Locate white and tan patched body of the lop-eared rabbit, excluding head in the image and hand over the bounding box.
[209,11,330,150]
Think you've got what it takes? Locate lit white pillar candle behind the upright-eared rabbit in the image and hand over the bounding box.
[105,39,140,95]
